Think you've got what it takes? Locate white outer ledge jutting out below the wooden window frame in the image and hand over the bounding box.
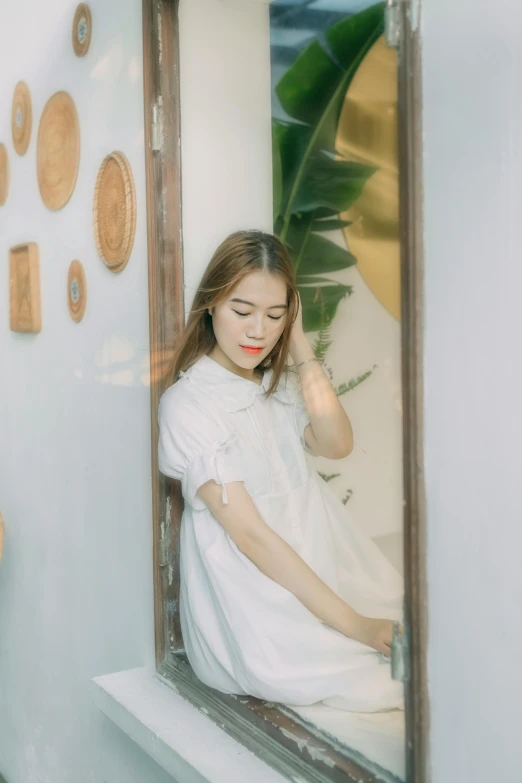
[92,668,287,783]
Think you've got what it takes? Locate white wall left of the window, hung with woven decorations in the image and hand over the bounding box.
[0,0,170,783]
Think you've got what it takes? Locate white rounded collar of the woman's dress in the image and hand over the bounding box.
[179,354,292,413]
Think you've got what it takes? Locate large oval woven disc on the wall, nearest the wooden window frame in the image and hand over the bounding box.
[93,152,136,272]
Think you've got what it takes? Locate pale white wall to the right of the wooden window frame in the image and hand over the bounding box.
[422,0,522,783]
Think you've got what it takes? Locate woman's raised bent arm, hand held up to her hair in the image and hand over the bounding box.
[289,306,353,459]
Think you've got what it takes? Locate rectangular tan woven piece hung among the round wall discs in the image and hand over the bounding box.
[9,242,42,332]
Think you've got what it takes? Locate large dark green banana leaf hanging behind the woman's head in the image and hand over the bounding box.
[272,2,384,331]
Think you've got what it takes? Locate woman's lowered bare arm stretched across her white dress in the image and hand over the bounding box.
[197,480,393,655]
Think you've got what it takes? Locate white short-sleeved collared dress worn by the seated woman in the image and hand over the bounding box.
[158,356,403,712]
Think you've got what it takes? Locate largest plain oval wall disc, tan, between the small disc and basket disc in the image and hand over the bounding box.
[37,92,80,209]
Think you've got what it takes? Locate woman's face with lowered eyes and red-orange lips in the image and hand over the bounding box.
[210,270,287,377]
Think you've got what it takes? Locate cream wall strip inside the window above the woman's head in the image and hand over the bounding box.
[180,0,272,315]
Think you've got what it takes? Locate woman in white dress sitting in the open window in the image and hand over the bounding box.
[159,231,403,712]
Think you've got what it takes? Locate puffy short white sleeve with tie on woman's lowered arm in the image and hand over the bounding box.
[158,386,244,510]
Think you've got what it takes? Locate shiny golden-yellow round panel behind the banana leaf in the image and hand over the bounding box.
[336,36,401,320]
